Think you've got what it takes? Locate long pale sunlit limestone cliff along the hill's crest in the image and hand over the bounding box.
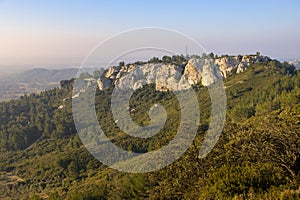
[97,55,270,91]
